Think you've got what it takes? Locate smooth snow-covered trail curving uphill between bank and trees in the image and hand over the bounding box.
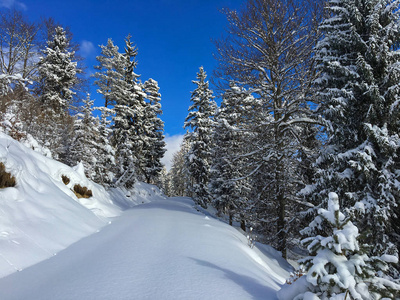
[0,198,288,300]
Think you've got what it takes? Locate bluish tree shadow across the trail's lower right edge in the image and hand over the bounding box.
[189,257,280,300]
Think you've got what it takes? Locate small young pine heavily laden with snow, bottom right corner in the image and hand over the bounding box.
[295,193,400,300]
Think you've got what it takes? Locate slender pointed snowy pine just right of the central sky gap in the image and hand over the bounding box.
[184,67,216,208]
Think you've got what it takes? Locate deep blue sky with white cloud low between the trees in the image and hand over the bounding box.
[0,0,243,169]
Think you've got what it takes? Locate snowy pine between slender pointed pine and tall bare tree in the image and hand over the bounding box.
[210,86,255,230]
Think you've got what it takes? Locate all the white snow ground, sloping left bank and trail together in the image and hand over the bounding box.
[0,134,290,300]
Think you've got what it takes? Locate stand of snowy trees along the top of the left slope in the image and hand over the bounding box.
[0,10,165,188]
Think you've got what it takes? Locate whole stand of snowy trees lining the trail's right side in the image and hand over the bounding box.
[164,0,400,299]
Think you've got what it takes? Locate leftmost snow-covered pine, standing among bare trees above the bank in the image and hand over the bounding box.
[35,27,77,162]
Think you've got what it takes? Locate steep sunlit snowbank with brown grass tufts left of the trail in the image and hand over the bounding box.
[0,133,121,277]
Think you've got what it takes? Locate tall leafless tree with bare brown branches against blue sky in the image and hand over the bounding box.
[214,0,323,257]
